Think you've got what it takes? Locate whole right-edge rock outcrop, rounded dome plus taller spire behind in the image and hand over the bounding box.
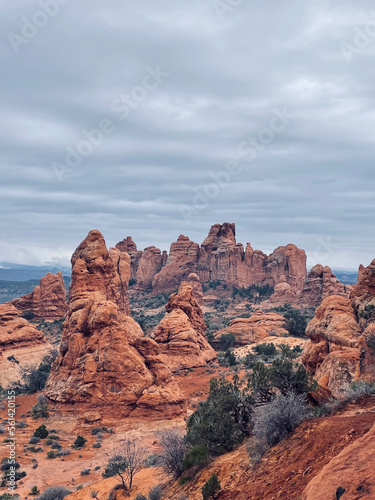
[302,261,375,397]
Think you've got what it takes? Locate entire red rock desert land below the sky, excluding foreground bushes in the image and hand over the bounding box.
[0,223,375,500]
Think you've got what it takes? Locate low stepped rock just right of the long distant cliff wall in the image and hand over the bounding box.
[299,264,352,306]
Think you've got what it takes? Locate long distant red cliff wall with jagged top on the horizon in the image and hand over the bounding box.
[116,222,312,297]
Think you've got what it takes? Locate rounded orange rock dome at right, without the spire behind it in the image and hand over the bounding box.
[302,295,375,397]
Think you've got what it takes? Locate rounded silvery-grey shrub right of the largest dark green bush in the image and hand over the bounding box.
[253,393,309,446]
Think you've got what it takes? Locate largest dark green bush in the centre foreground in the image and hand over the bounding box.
[187,375,253,454]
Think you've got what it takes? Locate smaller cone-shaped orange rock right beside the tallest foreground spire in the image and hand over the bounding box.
[153,282,216,371]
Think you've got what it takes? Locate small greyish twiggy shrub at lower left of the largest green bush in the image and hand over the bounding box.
[159,429,188,477]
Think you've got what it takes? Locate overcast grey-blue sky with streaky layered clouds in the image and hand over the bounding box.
[0,0,375,269]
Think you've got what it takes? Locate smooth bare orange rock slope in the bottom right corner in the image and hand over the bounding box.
[302,425,375,500]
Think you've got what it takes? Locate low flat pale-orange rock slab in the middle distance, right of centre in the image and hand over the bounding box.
[215,311,288,345]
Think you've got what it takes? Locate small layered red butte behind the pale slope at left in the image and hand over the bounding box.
[11,271,67,319]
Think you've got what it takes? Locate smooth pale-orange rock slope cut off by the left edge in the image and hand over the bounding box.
[0,302,53,388]
